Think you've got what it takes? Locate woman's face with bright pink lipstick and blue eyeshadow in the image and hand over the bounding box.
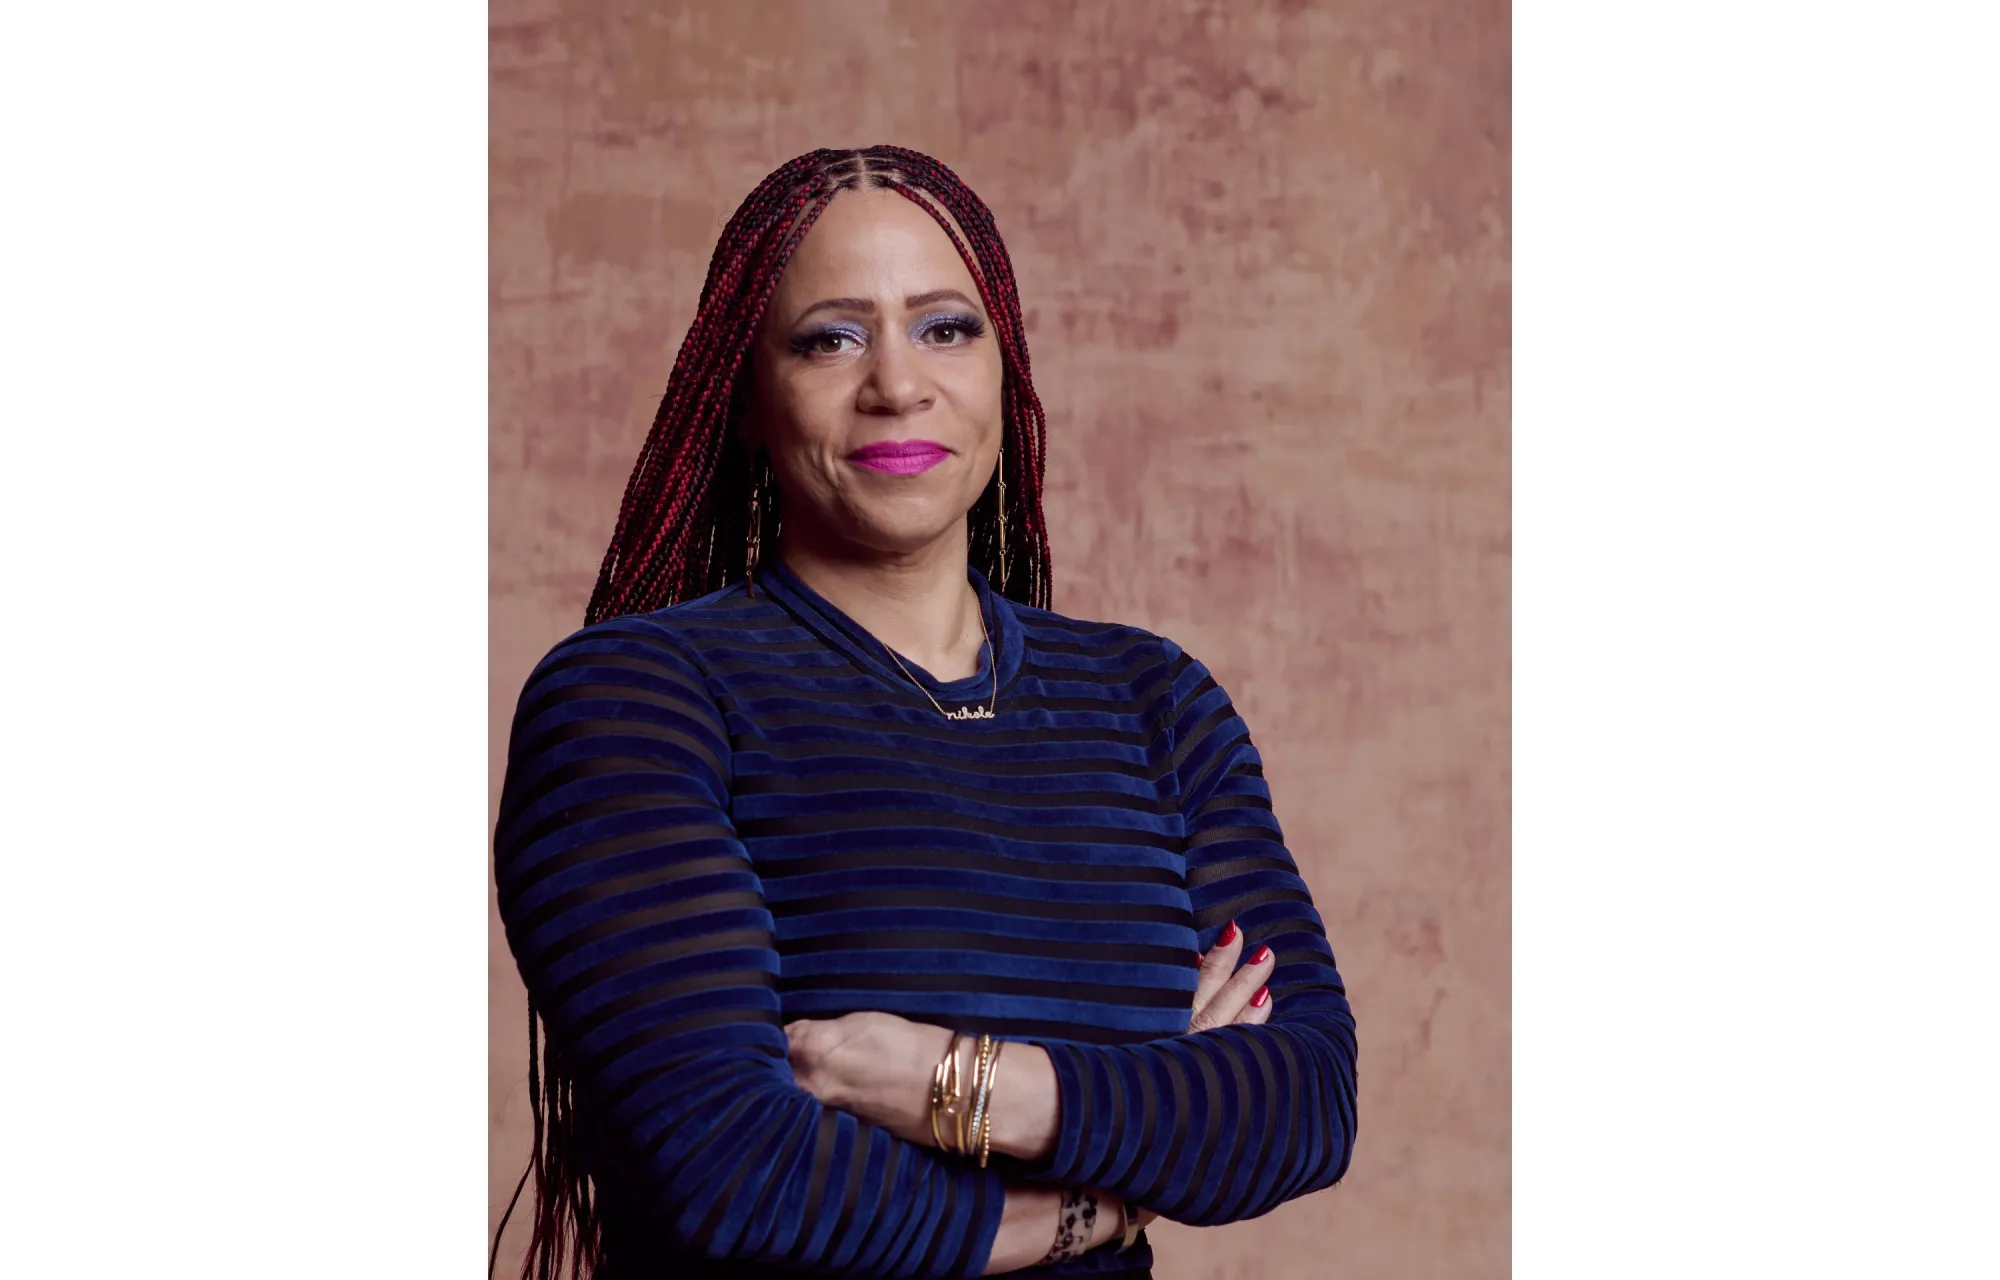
[744,190,1002,558]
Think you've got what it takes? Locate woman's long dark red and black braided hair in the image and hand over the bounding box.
[486,146,1050,1280]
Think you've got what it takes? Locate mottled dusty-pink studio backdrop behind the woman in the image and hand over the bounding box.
[490,0,1510,1280]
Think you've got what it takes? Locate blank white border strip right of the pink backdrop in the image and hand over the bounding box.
[1514,0,2000,1278]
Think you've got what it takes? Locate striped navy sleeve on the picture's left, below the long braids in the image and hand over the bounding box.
[494,618,1004,1276]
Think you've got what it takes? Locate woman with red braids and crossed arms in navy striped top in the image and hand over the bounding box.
[496,146,1354,1280]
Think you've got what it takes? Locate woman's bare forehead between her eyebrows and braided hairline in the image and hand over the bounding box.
[772,190,978,306]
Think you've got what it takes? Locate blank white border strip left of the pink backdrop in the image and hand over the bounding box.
[0,2,486,1276]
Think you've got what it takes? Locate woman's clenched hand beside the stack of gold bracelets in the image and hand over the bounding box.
[784,1012,952,1146]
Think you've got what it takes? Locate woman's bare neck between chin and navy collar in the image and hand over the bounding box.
[778,522,986,680]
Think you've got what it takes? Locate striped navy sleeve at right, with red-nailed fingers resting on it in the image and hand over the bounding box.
[1044,640,1356,1226]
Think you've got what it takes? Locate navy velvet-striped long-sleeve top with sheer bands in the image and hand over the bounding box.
[494,564,1356,1280]
